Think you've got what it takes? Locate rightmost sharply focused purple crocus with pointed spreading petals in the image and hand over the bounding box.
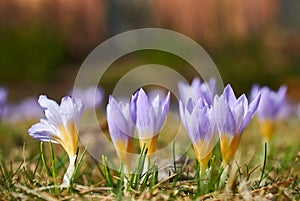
[213,85,260,167]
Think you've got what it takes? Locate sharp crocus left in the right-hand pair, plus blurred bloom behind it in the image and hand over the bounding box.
[178,78,216,175]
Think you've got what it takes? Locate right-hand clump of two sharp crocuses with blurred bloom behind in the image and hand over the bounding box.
[179,78,260,171]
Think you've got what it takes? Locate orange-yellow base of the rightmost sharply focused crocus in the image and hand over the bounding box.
[220,134,240,168]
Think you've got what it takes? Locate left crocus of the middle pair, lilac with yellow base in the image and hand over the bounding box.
[106,96,136,170]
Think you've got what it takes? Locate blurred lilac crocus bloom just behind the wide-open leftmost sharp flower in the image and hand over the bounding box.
[69,86,104,110]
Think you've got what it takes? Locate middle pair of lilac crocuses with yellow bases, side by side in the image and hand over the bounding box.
[106,89,170,170]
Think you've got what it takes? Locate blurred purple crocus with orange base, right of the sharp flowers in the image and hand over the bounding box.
[251,85,287,142]
